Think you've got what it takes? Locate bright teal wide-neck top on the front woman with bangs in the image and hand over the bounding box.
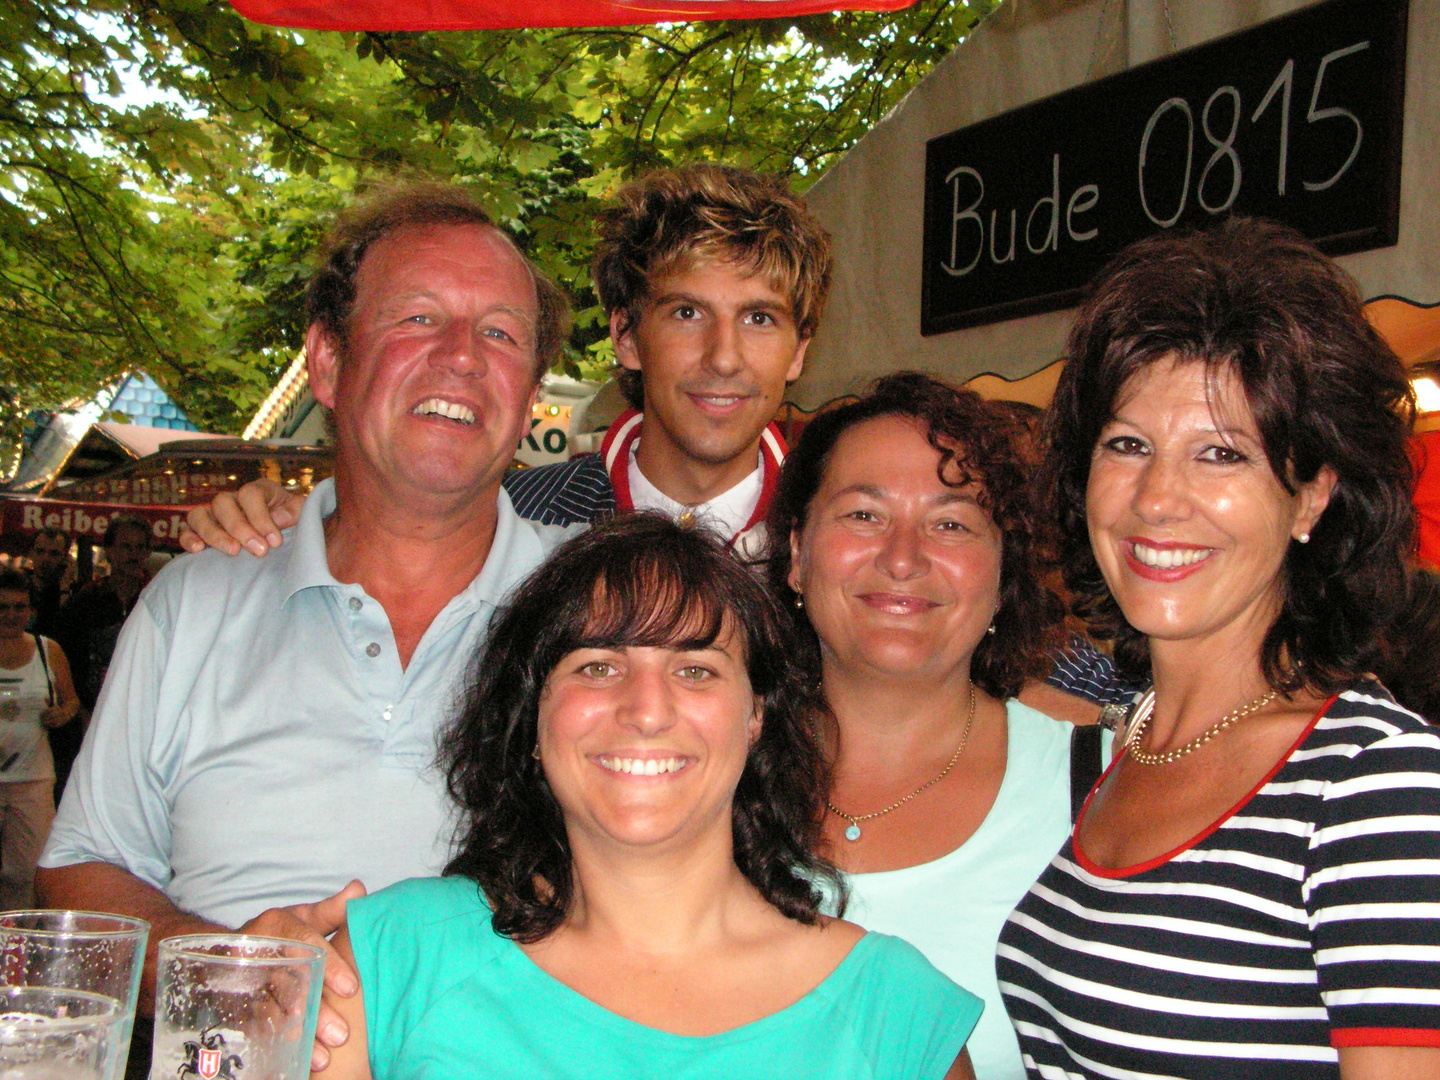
[348,877,984,1080]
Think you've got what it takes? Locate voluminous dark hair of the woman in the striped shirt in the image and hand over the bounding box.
[1045,219,1416,693]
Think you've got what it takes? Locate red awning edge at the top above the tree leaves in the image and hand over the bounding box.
[230,0,914,30]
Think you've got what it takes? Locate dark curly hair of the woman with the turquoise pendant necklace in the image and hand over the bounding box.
[766,372,1061,698]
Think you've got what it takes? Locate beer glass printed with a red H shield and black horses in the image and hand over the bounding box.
[150,933,325,1080]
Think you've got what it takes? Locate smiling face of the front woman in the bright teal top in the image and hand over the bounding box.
[539,632,760,847]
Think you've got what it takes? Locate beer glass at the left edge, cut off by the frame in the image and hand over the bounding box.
[0,912,150,1080]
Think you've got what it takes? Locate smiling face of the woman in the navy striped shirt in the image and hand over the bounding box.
[1086,359,1335,655]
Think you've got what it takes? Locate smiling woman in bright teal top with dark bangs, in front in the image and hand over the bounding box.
[325,514,982,1080]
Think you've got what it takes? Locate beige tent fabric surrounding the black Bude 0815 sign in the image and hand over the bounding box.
[789,0,1440,409]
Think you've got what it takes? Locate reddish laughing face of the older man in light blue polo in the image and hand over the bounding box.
[307,225,537,498]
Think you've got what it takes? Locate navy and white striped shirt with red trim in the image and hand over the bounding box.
[995,683,1440,1080]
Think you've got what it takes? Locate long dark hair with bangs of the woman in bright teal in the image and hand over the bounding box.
[441,514,844,942]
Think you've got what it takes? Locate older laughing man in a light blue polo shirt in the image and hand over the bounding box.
[37,186,566,1064]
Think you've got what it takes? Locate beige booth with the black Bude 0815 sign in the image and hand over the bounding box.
[792,0,1440,564]
